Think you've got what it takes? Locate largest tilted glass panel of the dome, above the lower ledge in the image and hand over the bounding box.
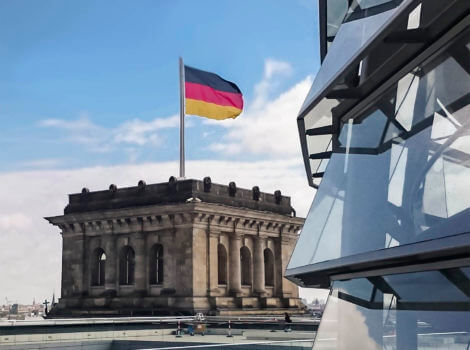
[289,31,470,268]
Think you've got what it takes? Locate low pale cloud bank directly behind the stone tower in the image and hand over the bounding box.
[0,160,313,302]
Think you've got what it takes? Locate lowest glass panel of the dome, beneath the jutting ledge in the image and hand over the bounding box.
[313,267,470,350]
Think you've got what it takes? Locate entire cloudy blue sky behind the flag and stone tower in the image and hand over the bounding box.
[0,0,319,303]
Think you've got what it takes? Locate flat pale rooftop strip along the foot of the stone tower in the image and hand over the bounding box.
[0,317,317,350]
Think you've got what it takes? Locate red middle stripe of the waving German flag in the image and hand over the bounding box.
[184,82,243,109]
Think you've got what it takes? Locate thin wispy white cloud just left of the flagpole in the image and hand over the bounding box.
[39,114,179,153]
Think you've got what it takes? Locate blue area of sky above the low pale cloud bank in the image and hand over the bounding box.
[0,0,318,171]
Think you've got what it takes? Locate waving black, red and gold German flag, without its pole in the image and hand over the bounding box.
[184,66,243,120]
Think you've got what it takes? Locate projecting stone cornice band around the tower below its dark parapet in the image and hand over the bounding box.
[46,203,304,239]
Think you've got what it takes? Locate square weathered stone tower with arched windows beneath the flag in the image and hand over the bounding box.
[46,177,304,317]
